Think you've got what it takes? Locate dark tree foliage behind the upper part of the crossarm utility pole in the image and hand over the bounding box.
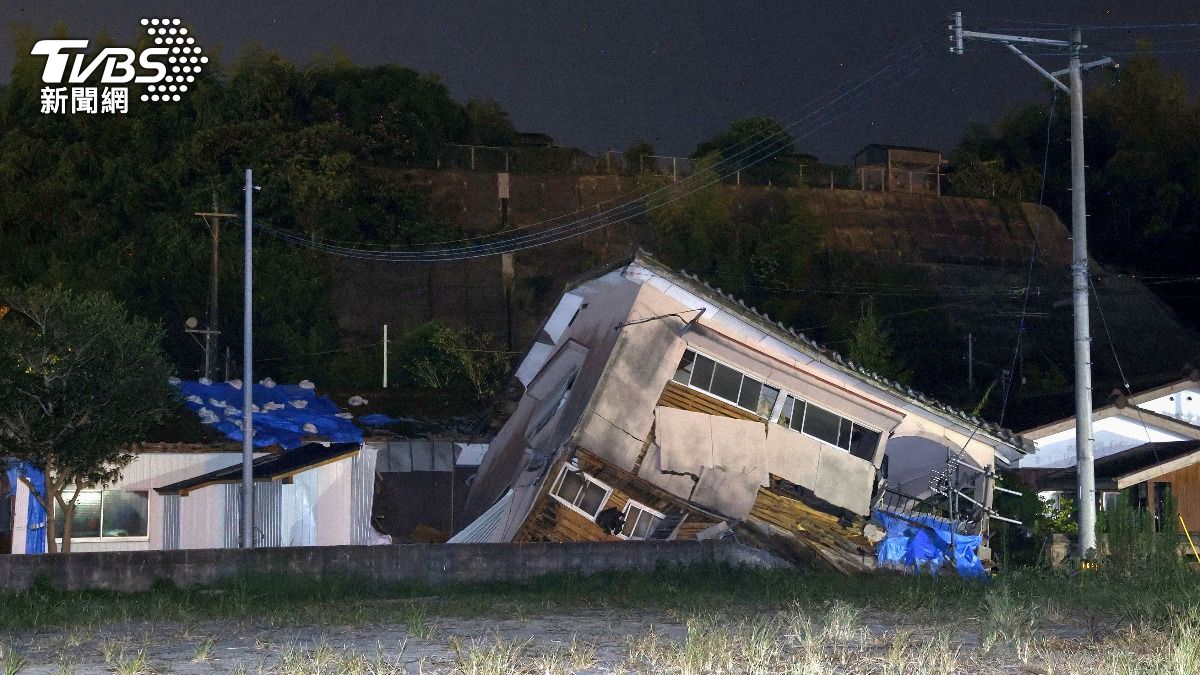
[949,54,1200,324]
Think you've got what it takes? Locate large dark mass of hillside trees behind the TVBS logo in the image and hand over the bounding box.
[0,26,511,380]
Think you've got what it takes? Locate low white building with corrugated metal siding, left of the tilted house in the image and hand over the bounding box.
[12,443,386,552]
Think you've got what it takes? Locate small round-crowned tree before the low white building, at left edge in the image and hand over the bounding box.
[0,287,175,552]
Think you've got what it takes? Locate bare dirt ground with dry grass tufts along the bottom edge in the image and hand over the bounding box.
[0,603,1161,675]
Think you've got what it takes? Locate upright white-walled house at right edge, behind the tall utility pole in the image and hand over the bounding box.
[1020,368,1200,530]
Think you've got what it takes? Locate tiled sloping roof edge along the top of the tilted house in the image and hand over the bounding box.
[626,251,1033,453]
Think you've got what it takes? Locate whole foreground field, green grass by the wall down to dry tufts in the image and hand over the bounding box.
[0,567,1200,675]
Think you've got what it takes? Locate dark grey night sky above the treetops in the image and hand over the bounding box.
[0,0,1200,161]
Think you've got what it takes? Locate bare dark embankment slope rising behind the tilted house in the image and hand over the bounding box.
[334,171,1200,428]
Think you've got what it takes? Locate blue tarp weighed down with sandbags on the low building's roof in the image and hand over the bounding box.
[172,380,362,450]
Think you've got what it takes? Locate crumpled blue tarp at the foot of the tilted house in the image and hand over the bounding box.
[875,510,986,577]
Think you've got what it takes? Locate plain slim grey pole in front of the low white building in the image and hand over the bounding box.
[241,169,254,549]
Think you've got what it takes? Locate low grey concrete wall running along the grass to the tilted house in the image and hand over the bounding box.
[0,540,786,591]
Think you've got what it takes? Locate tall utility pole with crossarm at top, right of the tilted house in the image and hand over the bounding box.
[949,12,1112,556]
